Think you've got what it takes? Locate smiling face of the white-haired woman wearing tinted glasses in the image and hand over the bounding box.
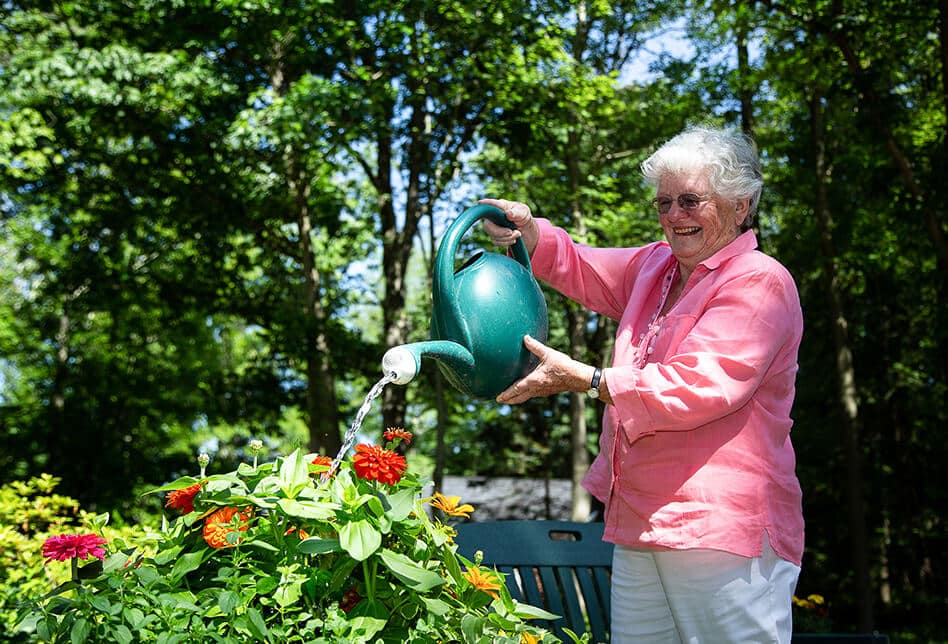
[656,170,746,273]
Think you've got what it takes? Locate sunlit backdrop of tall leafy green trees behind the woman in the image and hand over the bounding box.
[0,0,948,641]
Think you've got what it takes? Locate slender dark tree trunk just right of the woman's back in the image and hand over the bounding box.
[810,94,873,633]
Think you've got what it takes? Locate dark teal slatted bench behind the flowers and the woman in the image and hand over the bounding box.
[454,521,889,644]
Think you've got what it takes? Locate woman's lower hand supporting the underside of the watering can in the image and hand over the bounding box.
[497,335,593,405]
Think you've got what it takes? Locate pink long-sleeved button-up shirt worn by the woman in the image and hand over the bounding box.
[531,220,803,565]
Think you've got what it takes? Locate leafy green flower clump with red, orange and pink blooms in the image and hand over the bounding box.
[21,430,580,644]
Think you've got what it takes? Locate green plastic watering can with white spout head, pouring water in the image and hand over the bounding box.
[382,204,547,398]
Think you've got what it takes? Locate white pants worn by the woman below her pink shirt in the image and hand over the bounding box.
[611,534,800,644]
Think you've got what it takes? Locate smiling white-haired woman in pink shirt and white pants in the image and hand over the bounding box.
[481,127,803,644]
